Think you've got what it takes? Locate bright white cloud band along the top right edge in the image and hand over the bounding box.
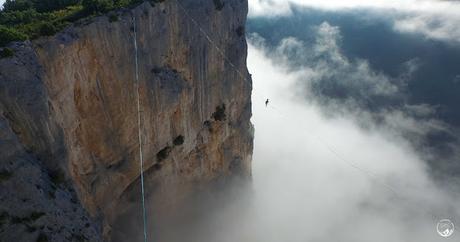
[249,0,460,43]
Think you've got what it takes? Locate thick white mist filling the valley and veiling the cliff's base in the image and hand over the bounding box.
[119,34,460,242]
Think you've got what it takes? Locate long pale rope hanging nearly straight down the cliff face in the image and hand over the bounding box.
[132,15,147,242]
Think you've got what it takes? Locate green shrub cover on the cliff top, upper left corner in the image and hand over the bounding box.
[0,0,163,47]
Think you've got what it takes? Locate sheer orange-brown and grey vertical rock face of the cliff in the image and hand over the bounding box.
[0,0,252,238]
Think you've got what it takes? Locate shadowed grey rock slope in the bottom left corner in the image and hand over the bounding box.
[0,115,101,241]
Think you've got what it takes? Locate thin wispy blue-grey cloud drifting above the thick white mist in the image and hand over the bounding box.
[251,22,448,142]
